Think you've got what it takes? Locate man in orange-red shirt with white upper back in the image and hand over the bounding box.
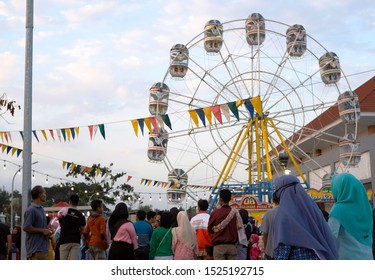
[190,199,212,260]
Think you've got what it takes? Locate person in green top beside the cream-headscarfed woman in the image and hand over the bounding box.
[150,211,173,260]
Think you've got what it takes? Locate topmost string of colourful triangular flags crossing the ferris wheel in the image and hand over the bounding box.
[0,96,263,143]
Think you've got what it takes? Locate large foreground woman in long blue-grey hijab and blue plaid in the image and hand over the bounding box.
[270,175,338,260]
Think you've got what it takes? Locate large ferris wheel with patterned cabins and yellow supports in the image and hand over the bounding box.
[148,13,360,206]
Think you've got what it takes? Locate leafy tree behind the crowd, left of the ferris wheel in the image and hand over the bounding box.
[66,163,141,211]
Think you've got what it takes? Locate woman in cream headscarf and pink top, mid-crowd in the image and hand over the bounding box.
[172,211,199,260]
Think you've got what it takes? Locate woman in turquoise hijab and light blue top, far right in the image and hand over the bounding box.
[328,173,373,260]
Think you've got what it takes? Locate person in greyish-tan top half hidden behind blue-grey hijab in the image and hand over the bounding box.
[260,198,278,260]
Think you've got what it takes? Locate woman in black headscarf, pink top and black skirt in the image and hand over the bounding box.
[108,202,138,260]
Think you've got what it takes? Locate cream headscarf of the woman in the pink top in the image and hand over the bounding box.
[173,211,197,249]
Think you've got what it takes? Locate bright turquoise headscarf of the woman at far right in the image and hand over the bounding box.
[329,173,373,246]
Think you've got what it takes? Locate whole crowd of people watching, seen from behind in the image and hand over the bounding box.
[0,173,375,260]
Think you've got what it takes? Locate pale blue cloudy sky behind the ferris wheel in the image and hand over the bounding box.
[0,0,375,208]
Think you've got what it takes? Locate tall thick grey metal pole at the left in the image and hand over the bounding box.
[21,0,34,260]
